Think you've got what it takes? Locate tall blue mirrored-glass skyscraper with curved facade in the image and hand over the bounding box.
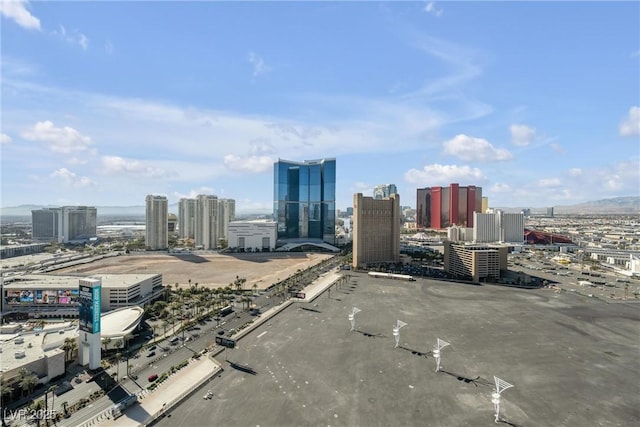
[273,159,336,244]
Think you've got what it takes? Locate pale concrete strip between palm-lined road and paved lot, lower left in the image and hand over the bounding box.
[91,356,221,427]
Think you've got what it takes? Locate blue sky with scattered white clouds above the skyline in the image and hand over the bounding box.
[0,0,640,212]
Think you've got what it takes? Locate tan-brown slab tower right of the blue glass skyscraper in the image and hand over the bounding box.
[352,193,401,267]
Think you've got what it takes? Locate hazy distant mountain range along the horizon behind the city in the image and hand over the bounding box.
[0,196,640,219]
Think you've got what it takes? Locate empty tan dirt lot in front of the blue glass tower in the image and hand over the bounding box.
[56,252,333,289]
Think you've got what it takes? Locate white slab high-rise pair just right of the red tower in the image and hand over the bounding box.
[473,210,524,243]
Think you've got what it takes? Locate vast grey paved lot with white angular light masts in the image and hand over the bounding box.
[151,274,640,427]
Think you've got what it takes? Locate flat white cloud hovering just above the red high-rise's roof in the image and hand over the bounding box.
[404,164,487,187]
